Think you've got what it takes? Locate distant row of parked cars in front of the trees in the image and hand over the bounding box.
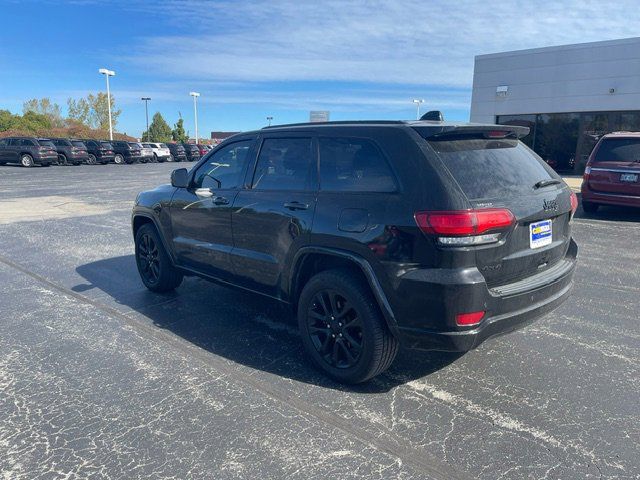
[0,137,213,167]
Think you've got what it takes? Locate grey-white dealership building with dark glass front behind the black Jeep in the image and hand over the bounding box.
[471,38,640,172]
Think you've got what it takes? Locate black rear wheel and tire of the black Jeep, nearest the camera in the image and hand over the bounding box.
[298,269,399,384]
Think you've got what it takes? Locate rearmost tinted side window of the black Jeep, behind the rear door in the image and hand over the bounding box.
[318,137,397,192]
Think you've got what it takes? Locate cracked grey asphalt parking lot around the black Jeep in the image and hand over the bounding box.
[0,164,640,479]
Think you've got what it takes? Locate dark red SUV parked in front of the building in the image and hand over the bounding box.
[582,132,640,213]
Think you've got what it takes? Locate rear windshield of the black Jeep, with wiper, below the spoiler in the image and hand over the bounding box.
[428,137,556,200]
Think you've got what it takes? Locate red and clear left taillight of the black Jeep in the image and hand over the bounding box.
[414,208,515,246]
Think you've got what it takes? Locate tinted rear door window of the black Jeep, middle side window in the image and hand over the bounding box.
[252,138,317,190]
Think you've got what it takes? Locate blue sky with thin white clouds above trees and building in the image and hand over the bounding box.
[0,0,640,136]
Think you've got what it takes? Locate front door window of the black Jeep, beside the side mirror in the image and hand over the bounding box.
[193,140,253,190]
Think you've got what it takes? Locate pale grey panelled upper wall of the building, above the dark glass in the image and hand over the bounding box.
[471,37,640,123]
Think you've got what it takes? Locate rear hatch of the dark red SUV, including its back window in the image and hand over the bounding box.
[586,137,640,196]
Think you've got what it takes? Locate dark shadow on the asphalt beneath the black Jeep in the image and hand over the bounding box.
[72,255,461,393]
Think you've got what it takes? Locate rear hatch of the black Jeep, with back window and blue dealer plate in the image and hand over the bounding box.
[416,127,572,287]
